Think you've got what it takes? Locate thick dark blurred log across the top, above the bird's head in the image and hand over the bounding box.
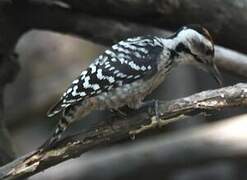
[30,0,247,53]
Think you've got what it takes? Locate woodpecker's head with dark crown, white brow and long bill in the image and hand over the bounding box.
[173,25,222,86]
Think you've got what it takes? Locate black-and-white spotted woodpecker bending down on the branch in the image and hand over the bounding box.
[42,25,222,146]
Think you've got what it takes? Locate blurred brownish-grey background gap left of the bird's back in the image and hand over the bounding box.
[5,31,104,153]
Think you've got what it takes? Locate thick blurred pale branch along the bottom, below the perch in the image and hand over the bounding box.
[34,115,247,180]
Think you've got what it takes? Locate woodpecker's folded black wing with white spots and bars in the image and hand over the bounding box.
[48,36,163,117]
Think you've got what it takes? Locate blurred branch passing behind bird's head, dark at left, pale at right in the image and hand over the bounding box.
[15,3,247,77]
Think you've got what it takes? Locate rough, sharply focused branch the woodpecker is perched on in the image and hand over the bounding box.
[0,84,247,179]
